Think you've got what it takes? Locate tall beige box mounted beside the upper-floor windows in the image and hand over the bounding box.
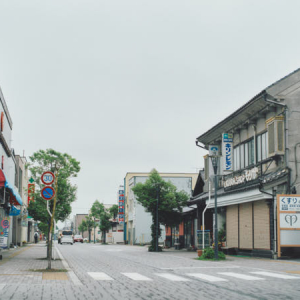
[266,117,284,157]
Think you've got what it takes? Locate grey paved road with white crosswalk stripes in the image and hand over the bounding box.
[0,244,300,300]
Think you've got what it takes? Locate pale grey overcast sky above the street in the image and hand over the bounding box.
[0,0,300,219]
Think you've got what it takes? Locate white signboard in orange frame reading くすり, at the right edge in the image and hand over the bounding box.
[277,194,300,257]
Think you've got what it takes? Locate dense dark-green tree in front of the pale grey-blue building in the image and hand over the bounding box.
[132,169,189,251]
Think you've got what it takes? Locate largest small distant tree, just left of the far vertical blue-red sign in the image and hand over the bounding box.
[91,200,113,244]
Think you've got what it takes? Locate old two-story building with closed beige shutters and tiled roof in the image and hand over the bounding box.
[189,69,300,257]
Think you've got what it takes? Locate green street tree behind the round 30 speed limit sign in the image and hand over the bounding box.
[28,149,80,268]
